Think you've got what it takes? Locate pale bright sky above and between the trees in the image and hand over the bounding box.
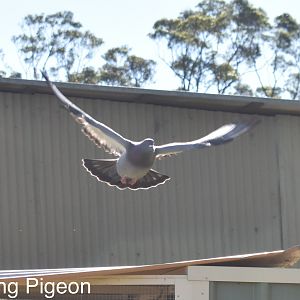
[0,0,300,90]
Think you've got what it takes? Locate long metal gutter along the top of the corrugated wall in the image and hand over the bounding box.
[0,78,300,115]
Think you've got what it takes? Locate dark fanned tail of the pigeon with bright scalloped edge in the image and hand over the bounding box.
[82,158,170,190]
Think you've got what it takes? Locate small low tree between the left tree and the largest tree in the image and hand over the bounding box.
[99,46,155,87]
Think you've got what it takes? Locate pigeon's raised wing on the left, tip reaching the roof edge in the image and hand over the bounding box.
[42,72,130,156]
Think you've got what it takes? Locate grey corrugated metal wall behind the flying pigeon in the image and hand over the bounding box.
[0,93,300,269]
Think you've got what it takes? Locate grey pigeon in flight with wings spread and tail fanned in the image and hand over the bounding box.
[42,72,258,190]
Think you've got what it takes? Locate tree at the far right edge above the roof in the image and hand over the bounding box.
[253,14,300,99]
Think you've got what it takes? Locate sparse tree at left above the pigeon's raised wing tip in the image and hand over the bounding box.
[12,11,103,80]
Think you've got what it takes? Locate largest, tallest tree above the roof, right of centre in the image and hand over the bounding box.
[150,0,270,94]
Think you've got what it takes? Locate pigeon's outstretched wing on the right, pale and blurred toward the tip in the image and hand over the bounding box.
[155,119,259,158]
